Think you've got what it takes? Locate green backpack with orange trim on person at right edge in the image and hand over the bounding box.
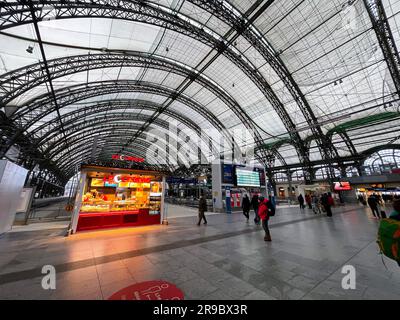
[377,219,400,266]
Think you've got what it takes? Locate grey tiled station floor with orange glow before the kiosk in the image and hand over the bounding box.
[0,207,400,300]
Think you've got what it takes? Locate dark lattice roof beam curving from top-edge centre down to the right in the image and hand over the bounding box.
[187,0,338,164]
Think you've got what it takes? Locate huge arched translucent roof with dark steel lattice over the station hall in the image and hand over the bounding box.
[0,0,400,181]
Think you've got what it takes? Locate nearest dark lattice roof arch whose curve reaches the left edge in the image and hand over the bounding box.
[0,0,308,165]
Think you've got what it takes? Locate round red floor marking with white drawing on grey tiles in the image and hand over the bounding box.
[108,280,184,300]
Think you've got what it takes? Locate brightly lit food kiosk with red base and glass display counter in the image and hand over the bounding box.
[70,166,165,233]
